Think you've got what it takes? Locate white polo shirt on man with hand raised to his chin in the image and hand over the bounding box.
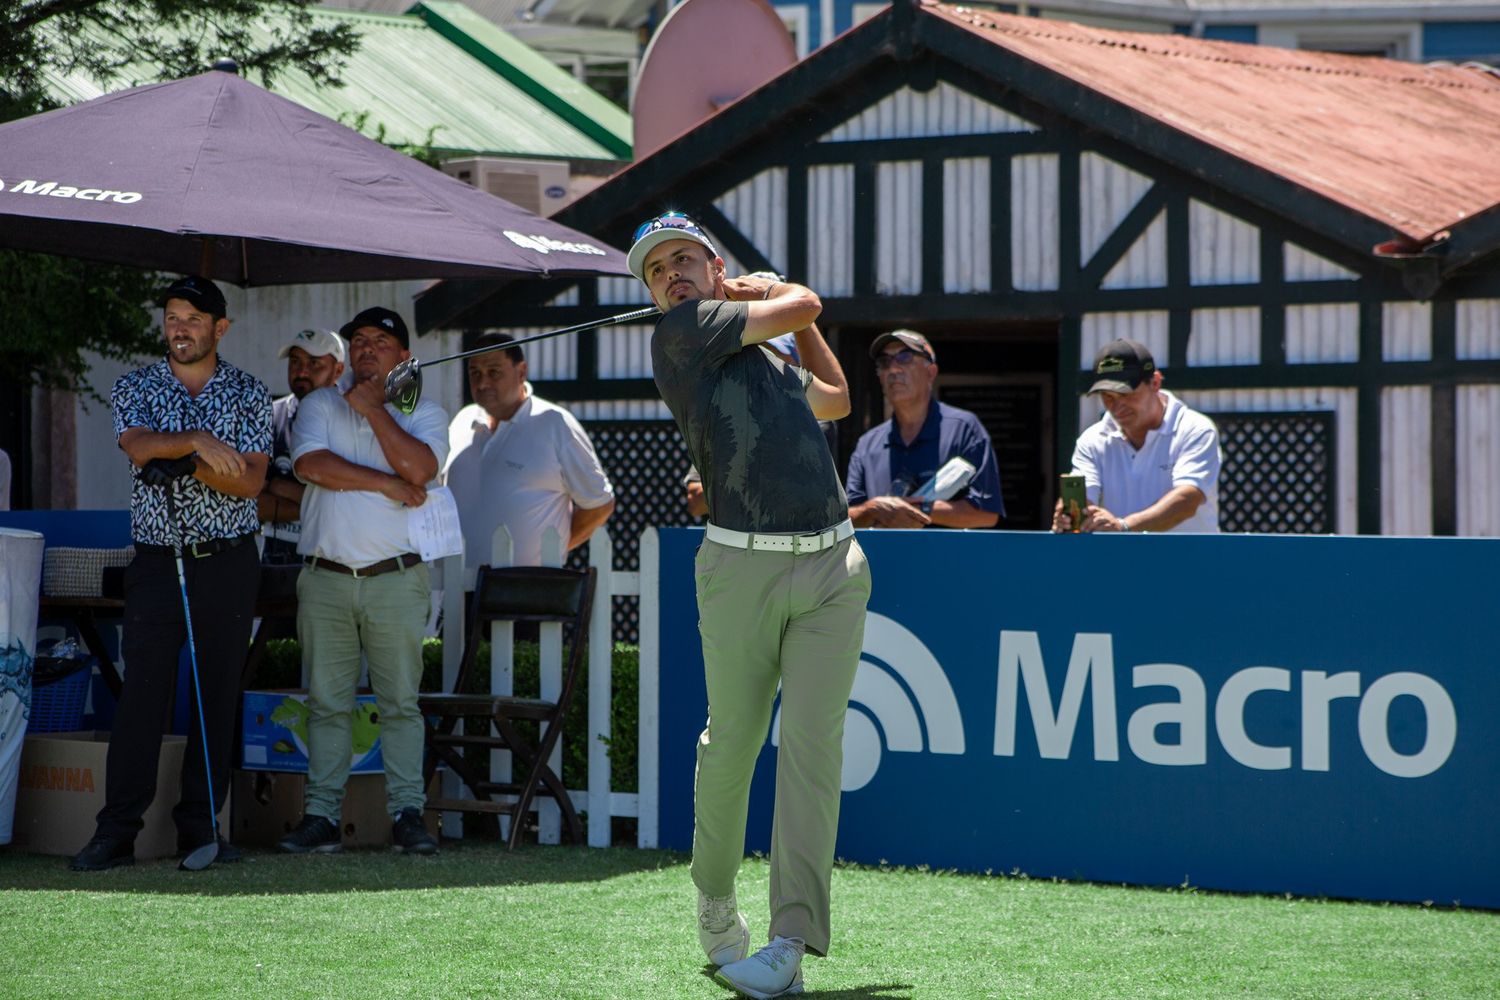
[291,387,449,568]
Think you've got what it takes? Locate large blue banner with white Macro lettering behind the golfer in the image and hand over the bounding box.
[660,529,1500,907]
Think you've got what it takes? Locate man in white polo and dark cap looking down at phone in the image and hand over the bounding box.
[1052,340,1220,532]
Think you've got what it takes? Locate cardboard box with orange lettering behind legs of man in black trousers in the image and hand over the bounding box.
[14,732,225,861]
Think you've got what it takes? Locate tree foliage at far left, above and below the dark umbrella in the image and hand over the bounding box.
[0,0,360,399]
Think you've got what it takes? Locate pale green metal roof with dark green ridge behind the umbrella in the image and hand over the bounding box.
[35,1,630,160]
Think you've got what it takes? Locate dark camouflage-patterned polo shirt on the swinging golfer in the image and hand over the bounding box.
[651,300,849,532]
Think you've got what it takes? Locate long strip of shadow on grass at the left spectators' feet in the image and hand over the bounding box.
[0,841,689,897]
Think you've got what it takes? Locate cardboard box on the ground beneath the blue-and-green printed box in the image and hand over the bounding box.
[230,771,438,847]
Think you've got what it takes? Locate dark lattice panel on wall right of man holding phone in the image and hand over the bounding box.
[1211,411,1338,535]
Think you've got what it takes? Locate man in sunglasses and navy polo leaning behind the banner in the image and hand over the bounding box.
[845,330,1005,528]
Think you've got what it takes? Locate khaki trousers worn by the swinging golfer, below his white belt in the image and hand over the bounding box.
[693,538,870,955]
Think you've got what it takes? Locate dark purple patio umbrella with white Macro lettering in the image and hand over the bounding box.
[0,72,630,285]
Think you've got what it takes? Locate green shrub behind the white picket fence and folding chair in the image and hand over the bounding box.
[255,639,641,792]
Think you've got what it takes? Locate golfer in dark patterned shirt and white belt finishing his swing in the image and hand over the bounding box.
[627,213,870,997]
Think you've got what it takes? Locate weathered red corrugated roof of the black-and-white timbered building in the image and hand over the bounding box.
[923,3,1500,243]
